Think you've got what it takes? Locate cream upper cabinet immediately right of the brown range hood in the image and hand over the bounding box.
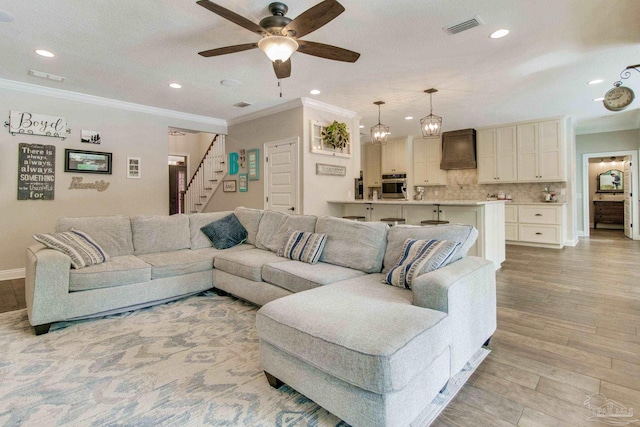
[477,126,518,184]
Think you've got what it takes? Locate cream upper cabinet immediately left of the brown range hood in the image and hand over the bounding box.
[413,138,447,186]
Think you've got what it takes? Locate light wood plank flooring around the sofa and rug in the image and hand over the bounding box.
[0,230,640,427]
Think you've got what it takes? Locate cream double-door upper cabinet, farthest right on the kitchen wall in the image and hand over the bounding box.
[516,120,566,182]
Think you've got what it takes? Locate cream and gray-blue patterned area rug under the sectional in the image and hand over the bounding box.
[0,292,488,427]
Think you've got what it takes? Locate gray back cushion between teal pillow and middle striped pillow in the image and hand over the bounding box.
[256,211,318,252]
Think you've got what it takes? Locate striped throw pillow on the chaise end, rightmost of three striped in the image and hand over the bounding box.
[385,239,460,289]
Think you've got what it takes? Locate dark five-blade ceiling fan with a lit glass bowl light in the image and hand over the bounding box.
[196,0,360,79]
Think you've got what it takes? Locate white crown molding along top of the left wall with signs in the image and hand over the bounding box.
[0,79,227,129]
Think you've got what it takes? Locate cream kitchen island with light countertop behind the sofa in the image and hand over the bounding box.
[329,200,505,270]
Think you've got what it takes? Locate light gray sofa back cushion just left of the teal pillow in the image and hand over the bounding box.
[131,214,191,255]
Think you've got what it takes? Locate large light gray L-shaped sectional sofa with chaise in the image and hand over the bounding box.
[26,208,496,426]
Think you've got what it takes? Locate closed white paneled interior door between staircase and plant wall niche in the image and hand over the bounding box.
[264,139,300,213]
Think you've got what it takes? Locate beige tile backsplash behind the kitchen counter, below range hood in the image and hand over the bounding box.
[412,169,567,202]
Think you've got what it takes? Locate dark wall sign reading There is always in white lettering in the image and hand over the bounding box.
[18,143,56,200]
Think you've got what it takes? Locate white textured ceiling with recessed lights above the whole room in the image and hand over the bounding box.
[0,0,640,139]
